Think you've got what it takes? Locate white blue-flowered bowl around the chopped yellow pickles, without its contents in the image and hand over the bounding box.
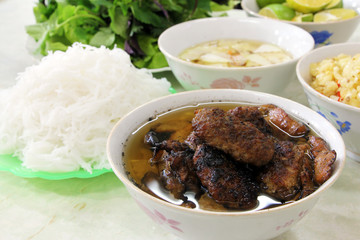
[296,43,360,162]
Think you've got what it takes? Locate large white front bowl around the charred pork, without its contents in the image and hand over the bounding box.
[107,89,345,240]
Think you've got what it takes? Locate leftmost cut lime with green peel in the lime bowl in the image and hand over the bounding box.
[259,3,295,20]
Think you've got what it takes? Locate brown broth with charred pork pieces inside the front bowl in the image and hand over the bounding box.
[124,103,336,211]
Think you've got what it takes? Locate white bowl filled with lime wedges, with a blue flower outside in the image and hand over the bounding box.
[241,0,360,47]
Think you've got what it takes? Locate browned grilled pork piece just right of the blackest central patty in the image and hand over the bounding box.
[259,141,309,201]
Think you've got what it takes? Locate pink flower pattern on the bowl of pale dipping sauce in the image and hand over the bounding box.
[210,76,261,89]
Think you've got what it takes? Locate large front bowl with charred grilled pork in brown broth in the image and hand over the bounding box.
[107,89,345,240]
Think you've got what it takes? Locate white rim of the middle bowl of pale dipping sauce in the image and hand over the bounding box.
[158,17,315,72]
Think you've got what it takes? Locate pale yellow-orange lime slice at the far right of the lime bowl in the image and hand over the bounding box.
[314,8,357,22]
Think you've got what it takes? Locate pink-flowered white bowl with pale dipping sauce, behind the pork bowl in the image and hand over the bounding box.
[158,17,314,94]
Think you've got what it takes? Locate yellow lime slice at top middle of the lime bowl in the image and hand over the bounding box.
[286,0,332,13]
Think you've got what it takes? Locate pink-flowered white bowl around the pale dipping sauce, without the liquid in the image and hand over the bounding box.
[158,17,314,94]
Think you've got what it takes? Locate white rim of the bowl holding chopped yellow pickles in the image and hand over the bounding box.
[295,42,360,113]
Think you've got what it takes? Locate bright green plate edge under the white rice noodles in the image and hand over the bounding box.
[0,155,112,180]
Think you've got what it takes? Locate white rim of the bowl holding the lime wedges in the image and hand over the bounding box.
[241,0,360,26]
